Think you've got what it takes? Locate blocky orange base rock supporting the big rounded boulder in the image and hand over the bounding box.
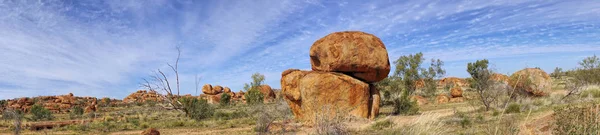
[281,70,379,121]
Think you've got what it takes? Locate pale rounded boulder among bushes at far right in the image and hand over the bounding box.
[509,68,552,96]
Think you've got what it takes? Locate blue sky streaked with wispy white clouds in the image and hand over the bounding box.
[0,0,600,99]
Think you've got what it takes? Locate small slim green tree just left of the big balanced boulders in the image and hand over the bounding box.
[244,73,265,104]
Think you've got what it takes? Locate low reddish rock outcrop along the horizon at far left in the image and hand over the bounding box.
[6,93,98,113]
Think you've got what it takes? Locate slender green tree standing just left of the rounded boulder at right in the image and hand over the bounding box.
[467,59,498,111]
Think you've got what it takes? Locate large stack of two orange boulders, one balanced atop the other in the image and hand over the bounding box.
[281,31,390,122]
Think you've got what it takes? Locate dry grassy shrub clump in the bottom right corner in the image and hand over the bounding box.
[553,103,600,135]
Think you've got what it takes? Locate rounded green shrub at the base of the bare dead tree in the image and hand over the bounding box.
[179,97,214,120]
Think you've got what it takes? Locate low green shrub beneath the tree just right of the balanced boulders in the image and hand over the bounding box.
[392,91,419,115]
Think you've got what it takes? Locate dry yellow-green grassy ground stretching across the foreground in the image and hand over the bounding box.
[0,80,600,135]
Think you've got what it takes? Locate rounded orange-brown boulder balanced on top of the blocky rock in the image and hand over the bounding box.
[310,31,390,83]
